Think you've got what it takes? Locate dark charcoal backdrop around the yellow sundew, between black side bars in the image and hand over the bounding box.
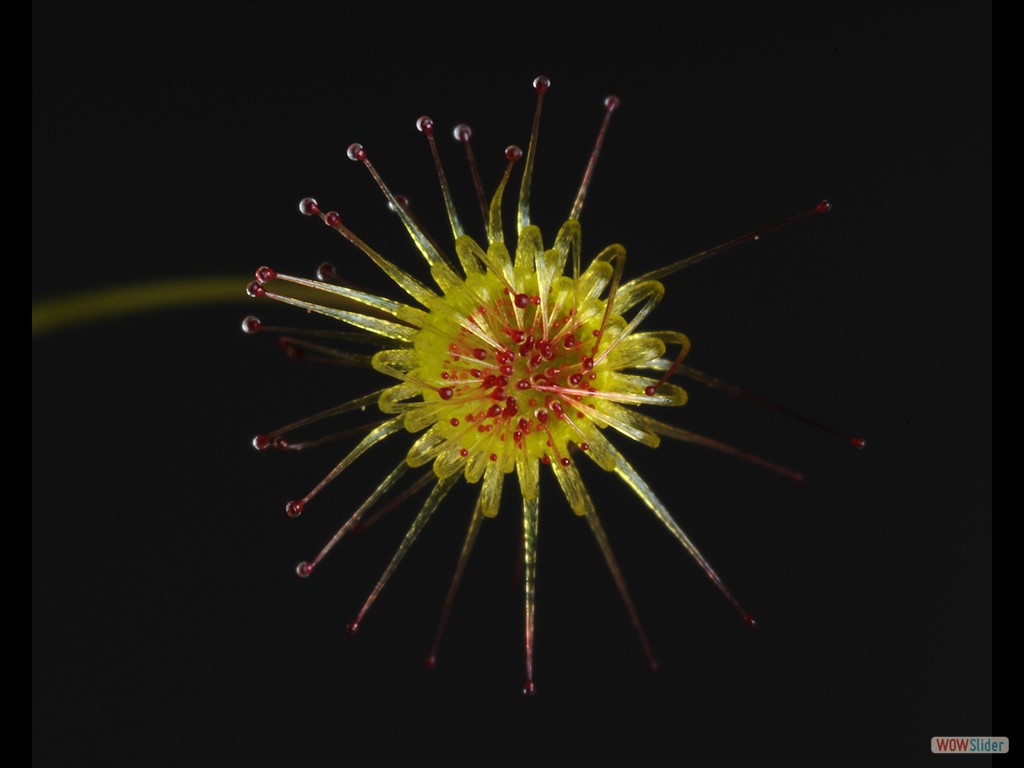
[32,3,991,766]
